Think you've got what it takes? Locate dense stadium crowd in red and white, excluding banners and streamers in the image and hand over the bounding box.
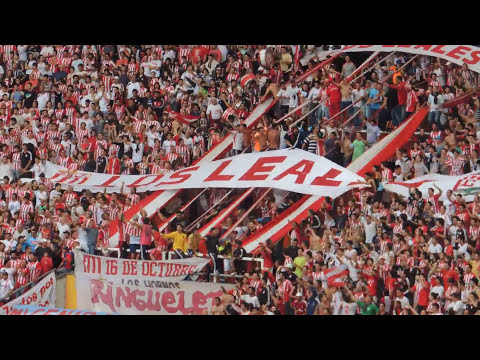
[0,45,480,315]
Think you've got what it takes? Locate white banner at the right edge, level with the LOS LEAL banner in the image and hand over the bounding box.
[384,171,480,201]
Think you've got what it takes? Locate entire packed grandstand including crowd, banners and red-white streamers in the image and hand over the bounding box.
[0,45,480,315]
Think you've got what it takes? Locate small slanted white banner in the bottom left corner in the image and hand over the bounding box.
[0,271,57,315]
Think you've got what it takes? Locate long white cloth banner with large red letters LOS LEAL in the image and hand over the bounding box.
[46,149,366,197]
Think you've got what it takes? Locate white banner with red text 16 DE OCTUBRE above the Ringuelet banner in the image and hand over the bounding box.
[75,250,210,286]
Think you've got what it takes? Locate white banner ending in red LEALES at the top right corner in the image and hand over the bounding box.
[316,45,480,73]
